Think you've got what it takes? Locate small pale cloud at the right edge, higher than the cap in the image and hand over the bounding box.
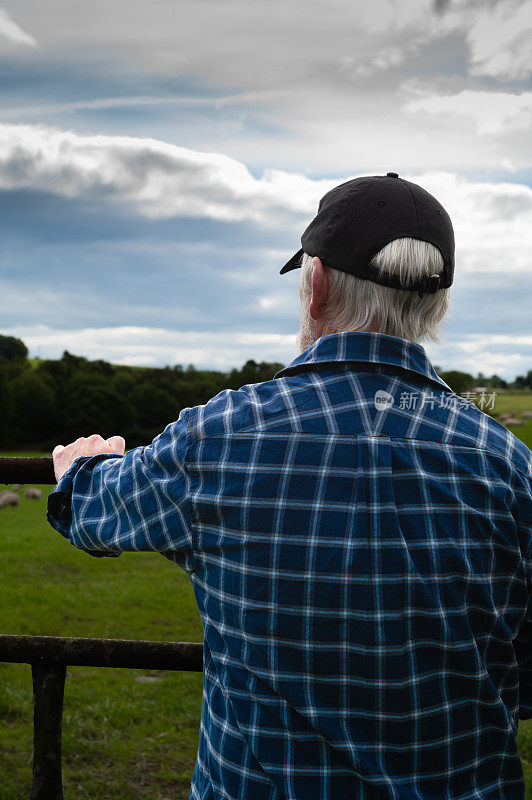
[404,89,532,135]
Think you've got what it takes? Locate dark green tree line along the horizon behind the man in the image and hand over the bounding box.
[0,335,532,451]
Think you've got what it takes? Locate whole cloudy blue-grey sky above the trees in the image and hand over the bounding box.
[0,0,532,378]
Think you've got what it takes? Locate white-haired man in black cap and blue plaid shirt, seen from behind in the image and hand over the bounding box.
[48,173,532,800]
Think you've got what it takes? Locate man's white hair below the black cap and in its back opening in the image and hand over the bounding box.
[299,238,450,342]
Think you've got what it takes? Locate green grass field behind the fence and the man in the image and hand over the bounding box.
[0,393,532,800]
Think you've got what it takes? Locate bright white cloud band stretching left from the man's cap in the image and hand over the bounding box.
[0,125,334,224]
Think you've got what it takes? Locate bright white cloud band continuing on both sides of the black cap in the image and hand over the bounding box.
[0,125,532,280]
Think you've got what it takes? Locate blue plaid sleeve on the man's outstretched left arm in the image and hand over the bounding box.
[46,409,193,571]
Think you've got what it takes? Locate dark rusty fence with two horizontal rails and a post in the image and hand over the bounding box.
[0,457,203,800]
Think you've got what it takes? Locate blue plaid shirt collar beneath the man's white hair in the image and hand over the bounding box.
[274,331,452,391]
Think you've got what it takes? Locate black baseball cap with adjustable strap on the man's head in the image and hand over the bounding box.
[280,172,454,297]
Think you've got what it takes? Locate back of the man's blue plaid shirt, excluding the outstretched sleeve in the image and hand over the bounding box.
[184,333,532,800]
